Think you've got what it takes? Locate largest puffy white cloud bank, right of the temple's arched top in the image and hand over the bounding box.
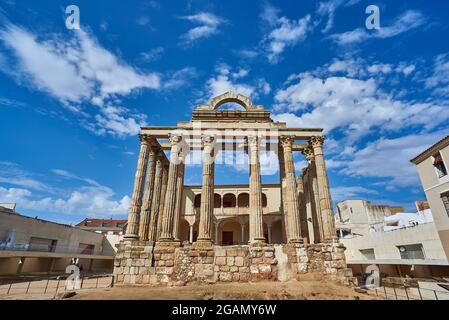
[273,74,449,141]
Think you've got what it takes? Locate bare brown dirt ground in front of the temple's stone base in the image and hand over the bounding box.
[65,280,377,300]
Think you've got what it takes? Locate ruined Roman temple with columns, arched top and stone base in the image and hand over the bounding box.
[114,92,350,285]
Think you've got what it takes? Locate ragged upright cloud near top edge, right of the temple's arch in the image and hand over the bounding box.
[261,4,312,63]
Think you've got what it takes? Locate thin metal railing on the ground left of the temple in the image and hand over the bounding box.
[0,275,113,297]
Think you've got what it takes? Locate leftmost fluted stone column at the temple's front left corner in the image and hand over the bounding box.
[125,135,150,239]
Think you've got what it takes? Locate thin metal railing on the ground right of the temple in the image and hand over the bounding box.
[367,285,449,300]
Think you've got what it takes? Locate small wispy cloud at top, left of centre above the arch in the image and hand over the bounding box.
[181,12,225,44]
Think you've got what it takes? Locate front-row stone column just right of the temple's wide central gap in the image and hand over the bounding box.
[247,136,265,244]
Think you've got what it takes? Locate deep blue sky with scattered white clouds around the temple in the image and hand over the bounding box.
[0,0,449,223]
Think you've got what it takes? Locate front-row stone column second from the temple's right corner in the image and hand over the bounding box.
[280,136,303,243]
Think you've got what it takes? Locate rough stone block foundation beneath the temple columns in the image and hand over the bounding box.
[114,241,353,286]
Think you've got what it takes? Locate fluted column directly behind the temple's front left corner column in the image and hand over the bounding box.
[139,146,158,241]
